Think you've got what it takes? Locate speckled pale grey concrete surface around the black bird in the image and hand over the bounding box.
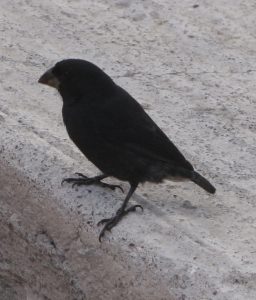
[0,0,256,300]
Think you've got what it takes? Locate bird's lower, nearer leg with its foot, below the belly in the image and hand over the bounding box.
[98,184,143,242]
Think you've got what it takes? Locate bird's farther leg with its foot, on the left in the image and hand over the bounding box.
[61,173,124,192]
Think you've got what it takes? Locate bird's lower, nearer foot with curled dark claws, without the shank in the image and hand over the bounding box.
[98,205,143,242]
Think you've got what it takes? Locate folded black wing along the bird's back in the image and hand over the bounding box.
[91,87,193,170]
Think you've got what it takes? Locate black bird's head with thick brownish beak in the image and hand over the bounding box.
[38,59,114,102]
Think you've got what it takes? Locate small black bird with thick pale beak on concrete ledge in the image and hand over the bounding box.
[38,59,216,241]
